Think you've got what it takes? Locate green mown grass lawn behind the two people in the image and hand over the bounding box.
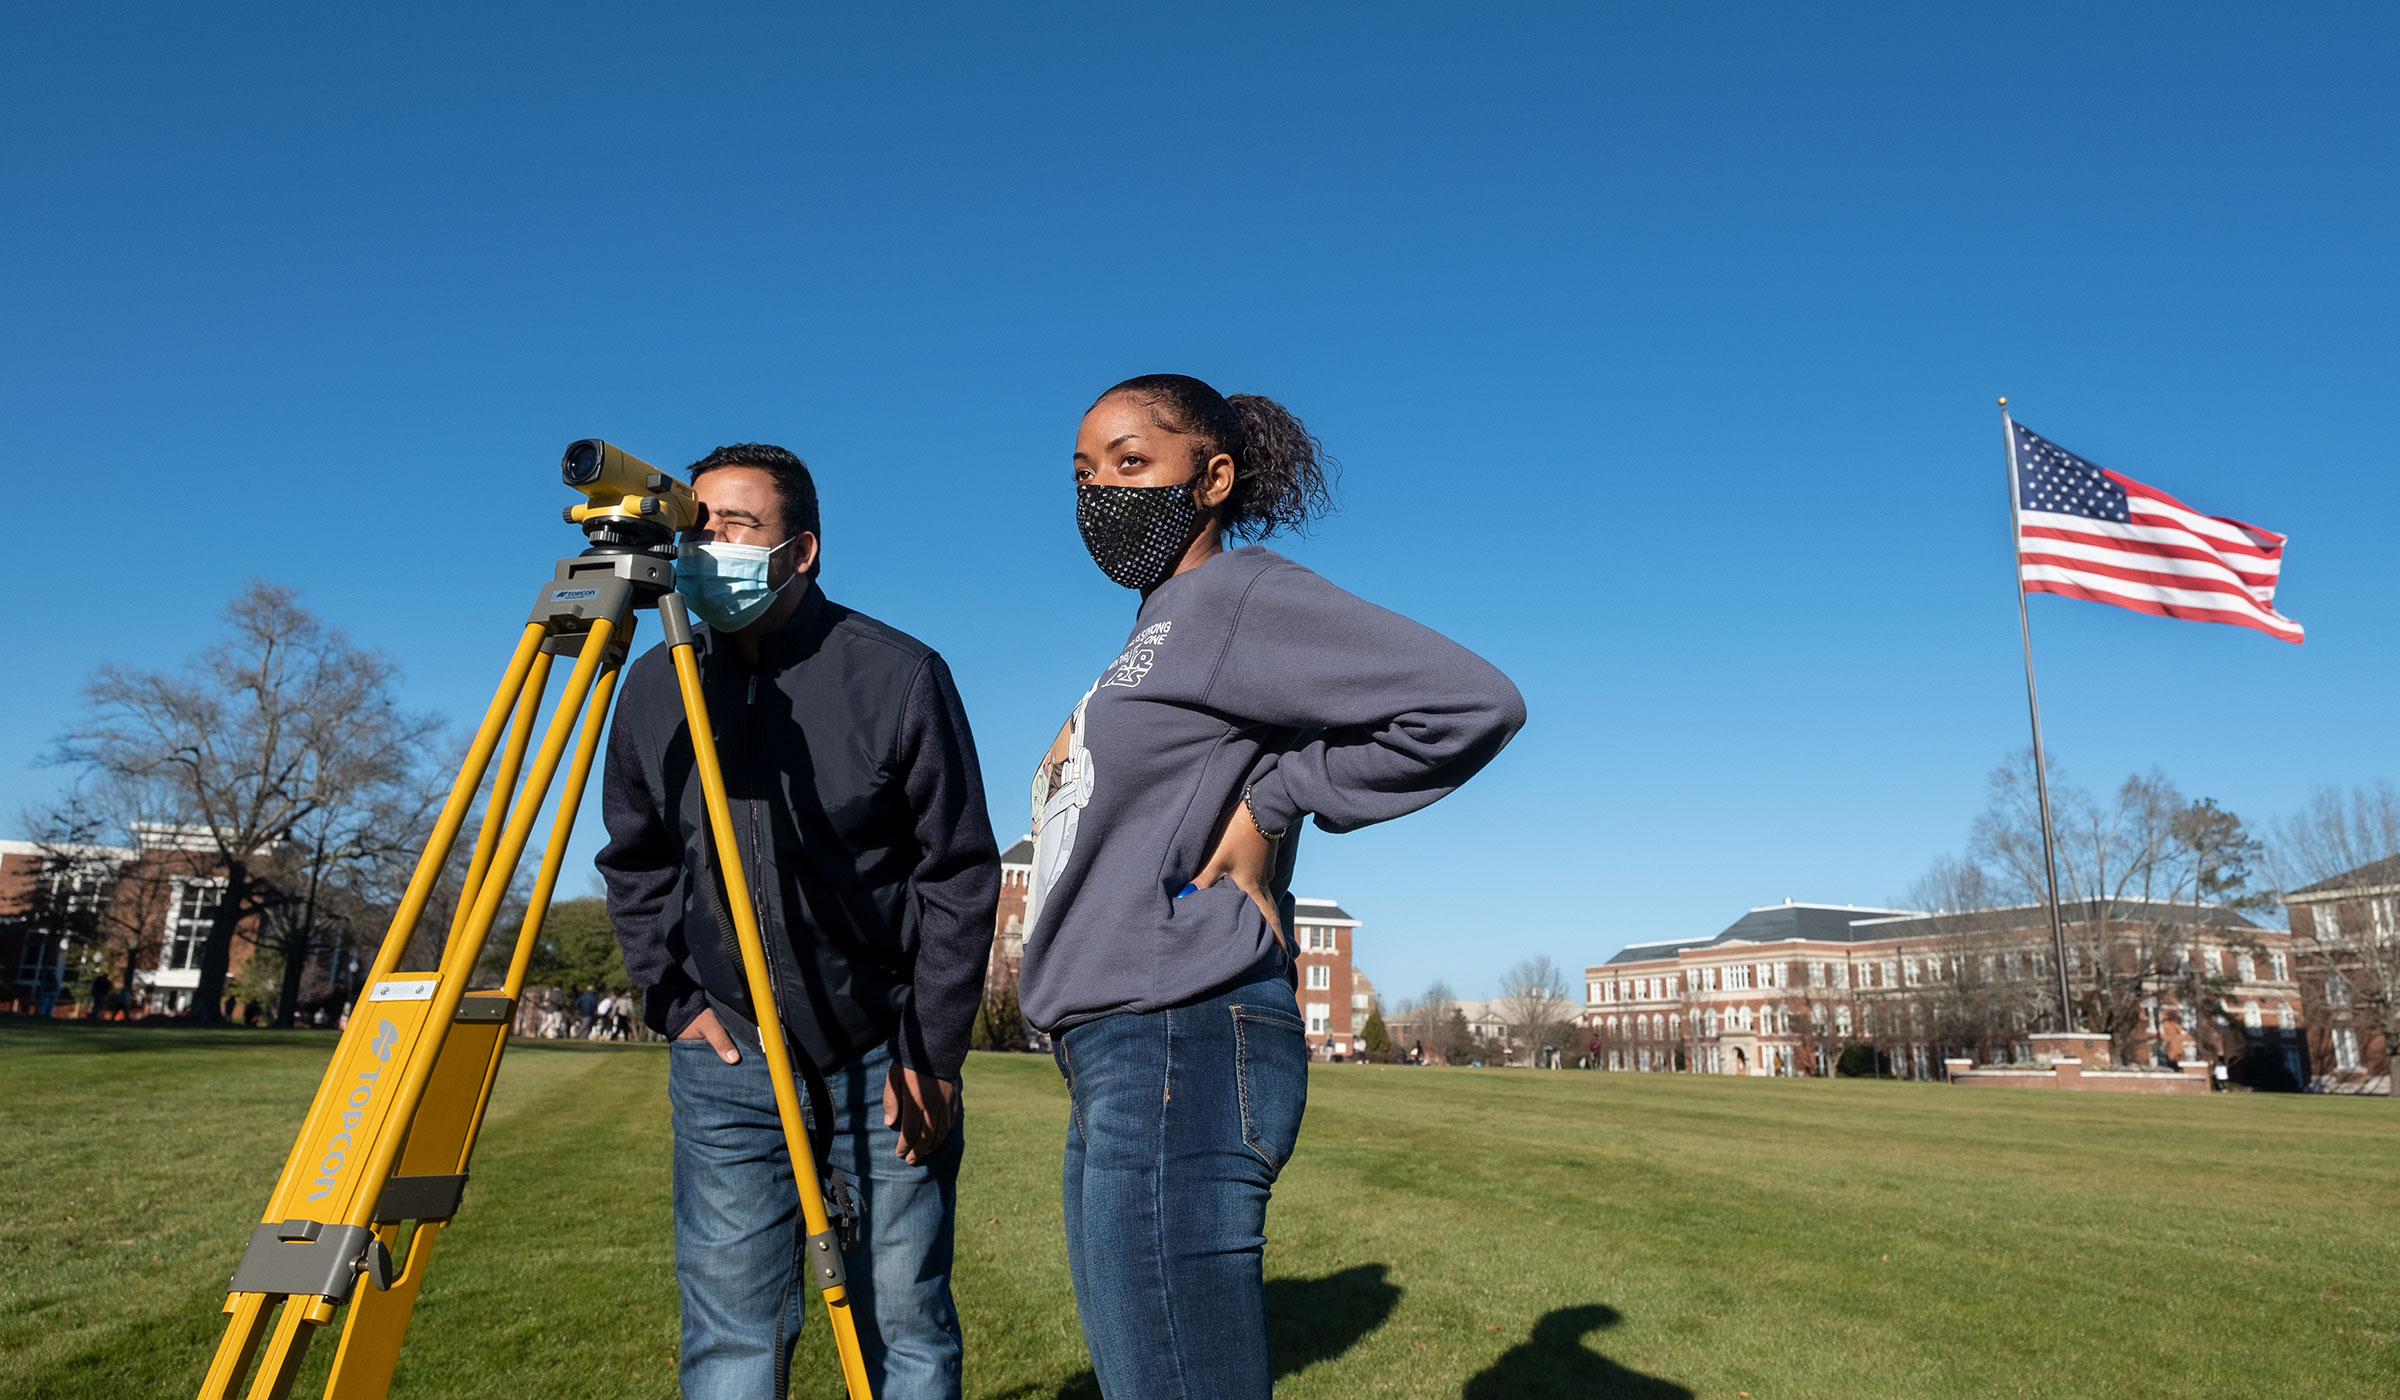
[0,1021,2400,1400]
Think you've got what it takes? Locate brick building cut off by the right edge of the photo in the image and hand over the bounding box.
[2282,855,2400,1095]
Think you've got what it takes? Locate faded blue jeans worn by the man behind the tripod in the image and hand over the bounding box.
[667,1040,965,1400]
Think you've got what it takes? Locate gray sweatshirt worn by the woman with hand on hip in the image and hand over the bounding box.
[1018,545,1524,1033]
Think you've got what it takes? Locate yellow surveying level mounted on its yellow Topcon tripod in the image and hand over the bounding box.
[199,439,871,1400]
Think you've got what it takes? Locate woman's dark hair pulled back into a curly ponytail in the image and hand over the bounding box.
[1094,375,1342,540]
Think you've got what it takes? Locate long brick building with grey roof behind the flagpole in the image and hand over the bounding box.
[1584,903,2304,1078]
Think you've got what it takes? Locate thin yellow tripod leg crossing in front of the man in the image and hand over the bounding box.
[658,593,874,1400]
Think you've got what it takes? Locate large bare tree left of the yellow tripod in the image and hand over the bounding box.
[60,579,437,1021]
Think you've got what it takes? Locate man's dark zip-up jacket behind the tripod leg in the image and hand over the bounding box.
[598,581,1001,1078]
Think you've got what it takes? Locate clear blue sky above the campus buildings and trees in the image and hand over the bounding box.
[0,5,2400,994]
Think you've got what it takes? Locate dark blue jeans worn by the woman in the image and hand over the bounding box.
[1056,975,1308,1400]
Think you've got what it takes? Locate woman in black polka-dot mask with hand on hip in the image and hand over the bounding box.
[1020,375,1524,1400]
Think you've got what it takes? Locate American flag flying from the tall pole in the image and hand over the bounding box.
[2009,420,2304,641]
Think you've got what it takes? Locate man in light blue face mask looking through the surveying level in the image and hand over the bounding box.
[598,442,1001,1400]
